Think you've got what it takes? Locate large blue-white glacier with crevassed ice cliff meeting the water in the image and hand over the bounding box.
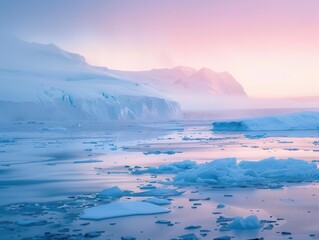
[0,37,181,121]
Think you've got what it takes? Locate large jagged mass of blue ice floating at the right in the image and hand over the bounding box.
[134,158,319,189]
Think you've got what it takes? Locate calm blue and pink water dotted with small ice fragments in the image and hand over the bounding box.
[0,121,319,240]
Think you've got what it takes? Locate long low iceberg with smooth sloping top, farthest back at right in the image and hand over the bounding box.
[213,112,319,131]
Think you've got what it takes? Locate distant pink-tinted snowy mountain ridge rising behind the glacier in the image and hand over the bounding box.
[109,66,246,96]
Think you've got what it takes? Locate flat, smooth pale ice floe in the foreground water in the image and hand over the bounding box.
[80,202,170,220]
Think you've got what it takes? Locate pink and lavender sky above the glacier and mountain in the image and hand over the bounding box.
[4,0,319,97]
